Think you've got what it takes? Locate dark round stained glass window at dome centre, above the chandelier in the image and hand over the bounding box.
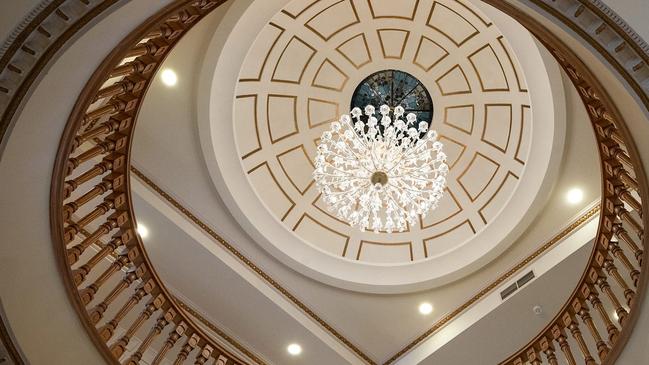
[350,70,433,123]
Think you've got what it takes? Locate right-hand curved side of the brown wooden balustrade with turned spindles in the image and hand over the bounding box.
[478,0,649,365]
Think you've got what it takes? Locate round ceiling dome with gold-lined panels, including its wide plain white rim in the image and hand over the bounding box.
[200,0,563,292]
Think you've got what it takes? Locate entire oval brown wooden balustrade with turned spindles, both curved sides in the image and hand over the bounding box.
[43,0,647,365]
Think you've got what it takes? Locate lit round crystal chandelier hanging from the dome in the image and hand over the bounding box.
[313,105,448,233]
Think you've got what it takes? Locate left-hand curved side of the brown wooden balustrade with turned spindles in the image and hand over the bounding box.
[52,0,251,365]
